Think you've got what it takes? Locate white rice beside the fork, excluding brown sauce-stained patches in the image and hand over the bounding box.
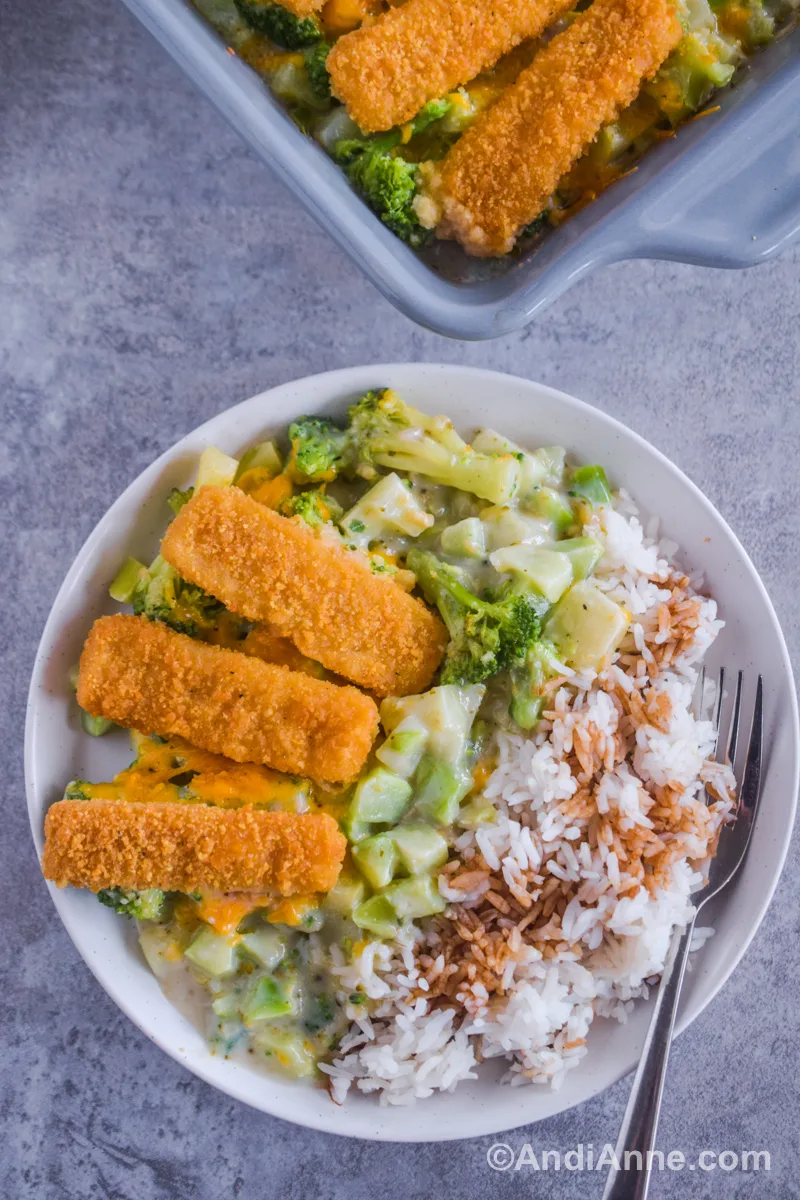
[321,492,733,1104]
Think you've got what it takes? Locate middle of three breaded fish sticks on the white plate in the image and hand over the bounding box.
[78,616,378,782]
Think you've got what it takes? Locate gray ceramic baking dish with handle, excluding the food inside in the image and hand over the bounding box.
[124,0,800,338]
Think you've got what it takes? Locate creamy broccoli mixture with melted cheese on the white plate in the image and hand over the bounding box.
[73,390,630,1076]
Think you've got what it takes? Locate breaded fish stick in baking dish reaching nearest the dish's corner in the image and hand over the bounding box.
[419,0,681,256]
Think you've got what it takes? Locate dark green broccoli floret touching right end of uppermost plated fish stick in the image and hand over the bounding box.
[407,550,541,684]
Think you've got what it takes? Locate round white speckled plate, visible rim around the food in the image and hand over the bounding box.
[25,365,800,1141]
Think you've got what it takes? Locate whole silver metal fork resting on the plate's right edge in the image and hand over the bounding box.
[603,671,764,1200]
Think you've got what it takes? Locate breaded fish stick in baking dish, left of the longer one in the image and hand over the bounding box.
[327,0,575,133]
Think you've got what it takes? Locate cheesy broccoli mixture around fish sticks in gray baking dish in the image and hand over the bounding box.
[192,0,798,258]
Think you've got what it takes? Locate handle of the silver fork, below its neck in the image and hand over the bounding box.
[603,913,696,1200]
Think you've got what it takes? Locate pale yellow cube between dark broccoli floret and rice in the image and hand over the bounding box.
[542,580,628,671]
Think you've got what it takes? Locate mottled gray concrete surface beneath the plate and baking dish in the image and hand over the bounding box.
[0,0,800,1200]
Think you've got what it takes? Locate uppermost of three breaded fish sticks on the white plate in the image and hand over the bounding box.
[161,487,447,696]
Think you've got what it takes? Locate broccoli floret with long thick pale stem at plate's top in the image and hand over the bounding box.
[350,388,522,504]
